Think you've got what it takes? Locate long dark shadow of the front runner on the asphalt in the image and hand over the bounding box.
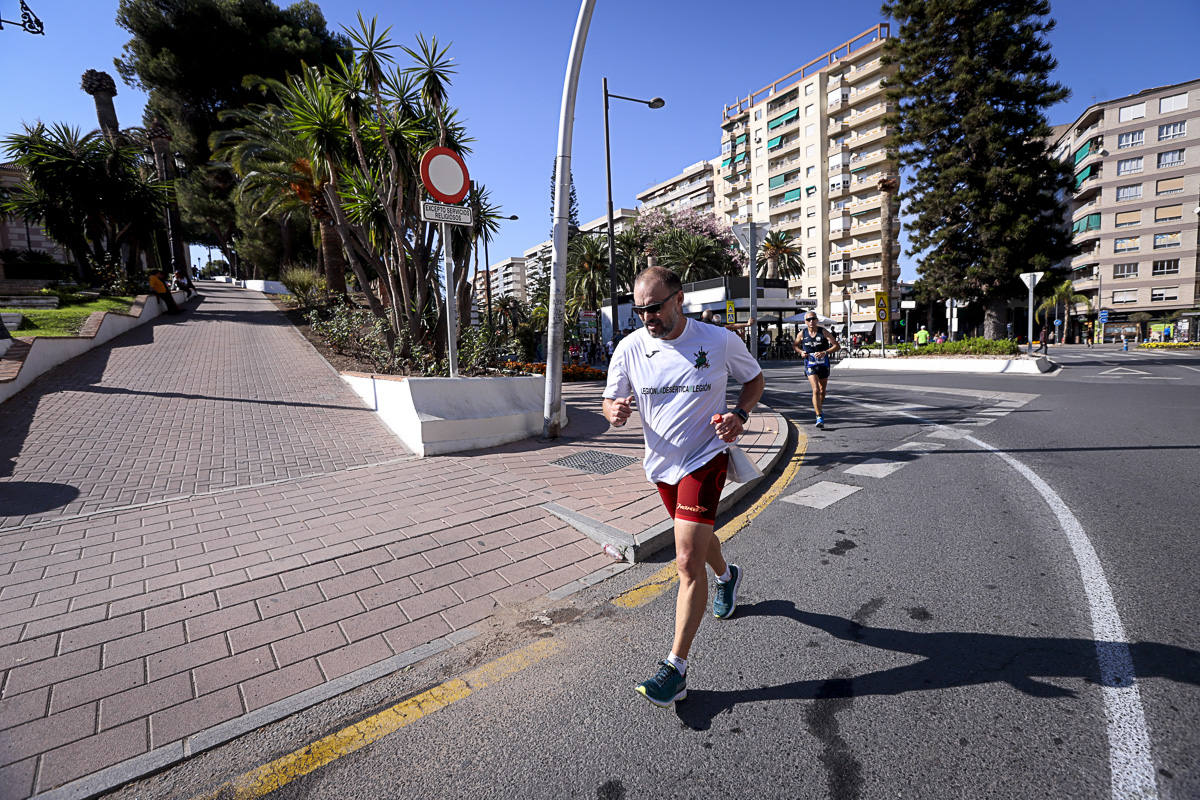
[676,600,1200,730]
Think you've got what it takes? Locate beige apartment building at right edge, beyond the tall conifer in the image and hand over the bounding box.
[1055,79,1200,341]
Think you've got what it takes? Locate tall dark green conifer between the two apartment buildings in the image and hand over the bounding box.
[883,0,1074,338]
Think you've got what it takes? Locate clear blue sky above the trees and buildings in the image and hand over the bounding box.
[0,0,1200,279]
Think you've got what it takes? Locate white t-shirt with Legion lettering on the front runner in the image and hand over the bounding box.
[604,319,762,483]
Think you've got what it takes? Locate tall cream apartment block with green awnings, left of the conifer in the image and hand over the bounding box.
[715,24,900,331]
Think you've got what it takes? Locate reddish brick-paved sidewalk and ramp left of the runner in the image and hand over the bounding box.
[0,288,779,798]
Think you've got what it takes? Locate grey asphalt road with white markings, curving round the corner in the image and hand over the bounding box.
[109,348,1200,800]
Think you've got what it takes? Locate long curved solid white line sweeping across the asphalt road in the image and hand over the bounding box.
[846,398,1158,800]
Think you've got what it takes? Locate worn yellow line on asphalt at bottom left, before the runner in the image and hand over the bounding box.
[193,639,562,800]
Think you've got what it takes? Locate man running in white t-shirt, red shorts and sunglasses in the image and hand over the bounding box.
[604,266,763,706]
